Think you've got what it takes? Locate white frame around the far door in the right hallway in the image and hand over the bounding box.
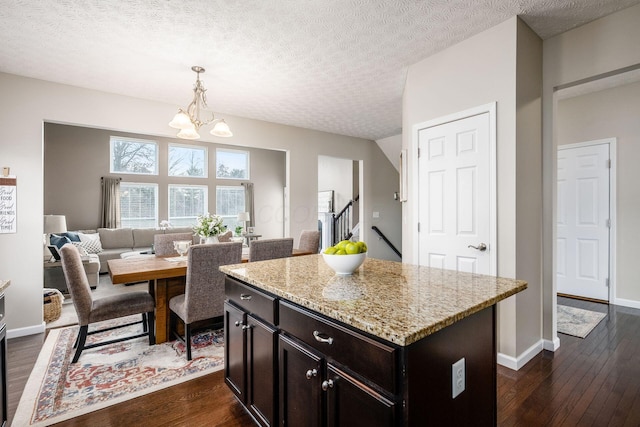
[553,137,618,304]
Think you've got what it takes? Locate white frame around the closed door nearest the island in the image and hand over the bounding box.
[410,102,498,276]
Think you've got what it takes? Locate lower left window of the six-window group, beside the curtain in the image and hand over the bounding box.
[120,182,158,228]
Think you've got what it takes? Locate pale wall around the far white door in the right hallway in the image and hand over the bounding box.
[555,83,640,306]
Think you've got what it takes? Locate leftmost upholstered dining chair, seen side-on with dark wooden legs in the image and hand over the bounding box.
[60,243,156,363]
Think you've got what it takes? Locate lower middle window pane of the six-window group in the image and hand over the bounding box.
[169,185,207,227]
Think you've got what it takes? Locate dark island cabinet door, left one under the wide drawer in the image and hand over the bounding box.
[279,335,324,427]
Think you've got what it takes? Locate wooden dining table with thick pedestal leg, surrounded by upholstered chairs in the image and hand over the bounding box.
[107,249,311,343]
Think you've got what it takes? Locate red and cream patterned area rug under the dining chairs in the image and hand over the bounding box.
[12,317,224,426]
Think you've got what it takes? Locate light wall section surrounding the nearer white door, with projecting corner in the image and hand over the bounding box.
[403,17,542,365]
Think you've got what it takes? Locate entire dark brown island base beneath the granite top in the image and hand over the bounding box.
[225,277,497,427]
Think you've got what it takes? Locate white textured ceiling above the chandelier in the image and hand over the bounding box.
[0,0,640,139]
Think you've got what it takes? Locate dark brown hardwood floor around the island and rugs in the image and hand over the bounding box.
[8,298,640,427]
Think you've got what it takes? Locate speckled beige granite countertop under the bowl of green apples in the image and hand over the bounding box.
[220,255,527,346]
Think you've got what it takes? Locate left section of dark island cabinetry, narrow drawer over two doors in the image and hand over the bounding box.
[225,281,277,426]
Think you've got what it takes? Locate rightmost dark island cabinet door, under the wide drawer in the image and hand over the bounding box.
[322,364,397,427]
